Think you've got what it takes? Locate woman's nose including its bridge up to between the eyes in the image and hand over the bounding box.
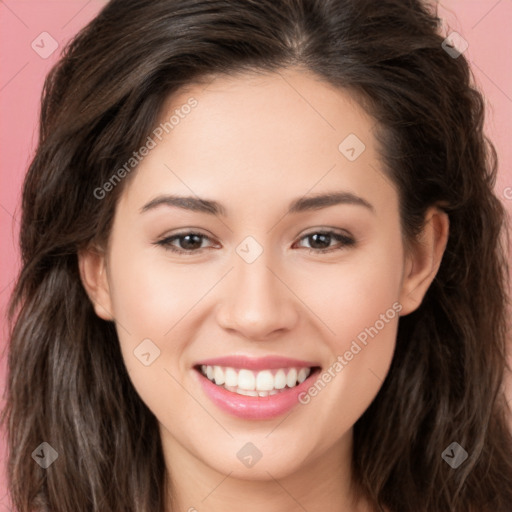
[219,237,297,338]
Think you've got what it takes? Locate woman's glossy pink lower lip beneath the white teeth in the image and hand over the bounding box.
[194,368,320,420]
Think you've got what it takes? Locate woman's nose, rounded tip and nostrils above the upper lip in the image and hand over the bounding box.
[217,247,300,341]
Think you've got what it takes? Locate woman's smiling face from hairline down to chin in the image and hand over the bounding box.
[80,70,444,479]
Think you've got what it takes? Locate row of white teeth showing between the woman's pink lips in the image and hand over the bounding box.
[194,364,320,398]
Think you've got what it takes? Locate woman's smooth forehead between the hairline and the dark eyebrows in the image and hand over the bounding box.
[118,69,394,218]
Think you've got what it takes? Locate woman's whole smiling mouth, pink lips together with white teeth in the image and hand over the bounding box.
[194,356,320,419]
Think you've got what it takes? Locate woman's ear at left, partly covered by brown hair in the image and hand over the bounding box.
[78,247,114,320]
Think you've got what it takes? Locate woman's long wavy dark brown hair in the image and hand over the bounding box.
[2,0,512,512]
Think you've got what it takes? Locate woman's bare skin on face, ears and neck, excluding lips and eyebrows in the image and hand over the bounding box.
[80,68,448,512]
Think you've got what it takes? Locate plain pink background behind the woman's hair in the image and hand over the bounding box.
[0,0,512,504]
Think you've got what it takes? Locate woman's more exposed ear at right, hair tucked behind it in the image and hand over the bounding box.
[400,207,450,316]
